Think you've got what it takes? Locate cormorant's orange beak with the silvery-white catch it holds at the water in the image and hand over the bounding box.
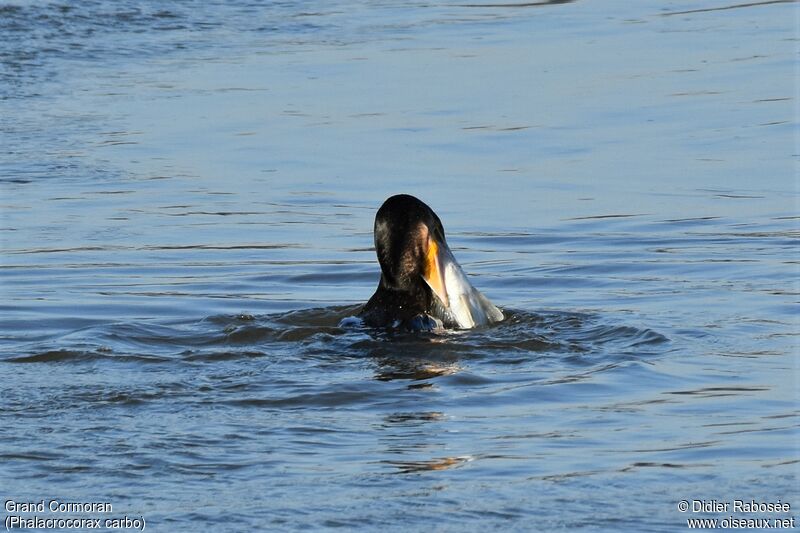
[422,234,503,328]
